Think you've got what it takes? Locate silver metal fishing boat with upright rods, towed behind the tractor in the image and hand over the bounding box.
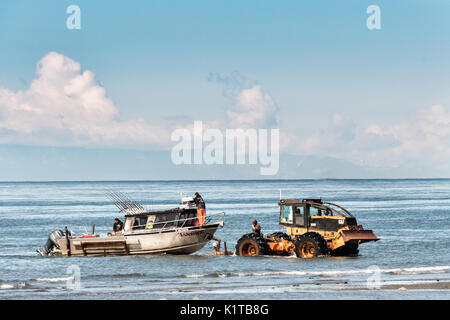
[37,191,225,256]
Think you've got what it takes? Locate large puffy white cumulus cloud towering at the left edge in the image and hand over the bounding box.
[0,52,169,146]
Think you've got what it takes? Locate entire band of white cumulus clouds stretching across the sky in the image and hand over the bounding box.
[0,52,450,176]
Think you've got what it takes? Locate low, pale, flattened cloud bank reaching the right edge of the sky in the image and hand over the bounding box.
[291,105,450,168]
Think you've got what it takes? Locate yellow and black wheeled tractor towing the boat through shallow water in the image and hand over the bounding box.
[236,199,380,258]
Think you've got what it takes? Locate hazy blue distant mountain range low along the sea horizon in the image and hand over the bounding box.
[0,145,448,181]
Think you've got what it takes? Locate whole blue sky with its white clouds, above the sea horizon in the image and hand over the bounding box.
[0,0,450,181]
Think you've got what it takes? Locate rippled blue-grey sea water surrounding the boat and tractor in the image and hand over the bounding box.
[0,179,450,299]
